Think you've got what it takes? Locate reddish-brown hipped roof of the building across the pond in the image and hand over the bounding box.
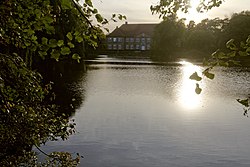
[108,23,157,37]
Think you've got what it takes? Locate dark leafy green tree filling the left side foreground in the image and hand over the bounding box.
[0,0,125,166]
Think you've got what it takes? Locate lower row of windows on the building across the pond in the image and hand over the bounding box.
[108,44,150,50]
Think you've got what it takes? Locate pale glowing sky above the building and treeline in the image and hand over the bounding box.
[92,0,250,31]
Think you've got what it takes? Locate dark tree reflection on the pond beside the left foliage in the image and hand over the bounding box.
[36,61,85,117]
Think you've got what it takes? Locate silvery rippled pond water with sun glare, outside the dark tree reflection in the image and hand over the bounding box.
[42,58,250,167]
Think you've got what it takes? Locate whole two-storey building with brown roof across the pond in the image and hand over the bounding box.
[106,22,157,51]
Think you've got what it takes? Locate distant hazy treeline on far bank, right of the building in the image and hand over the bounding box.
[152,11,250,60]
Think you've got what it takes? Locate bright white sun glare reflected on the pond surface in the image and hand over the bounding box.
[178,61,202,110]
